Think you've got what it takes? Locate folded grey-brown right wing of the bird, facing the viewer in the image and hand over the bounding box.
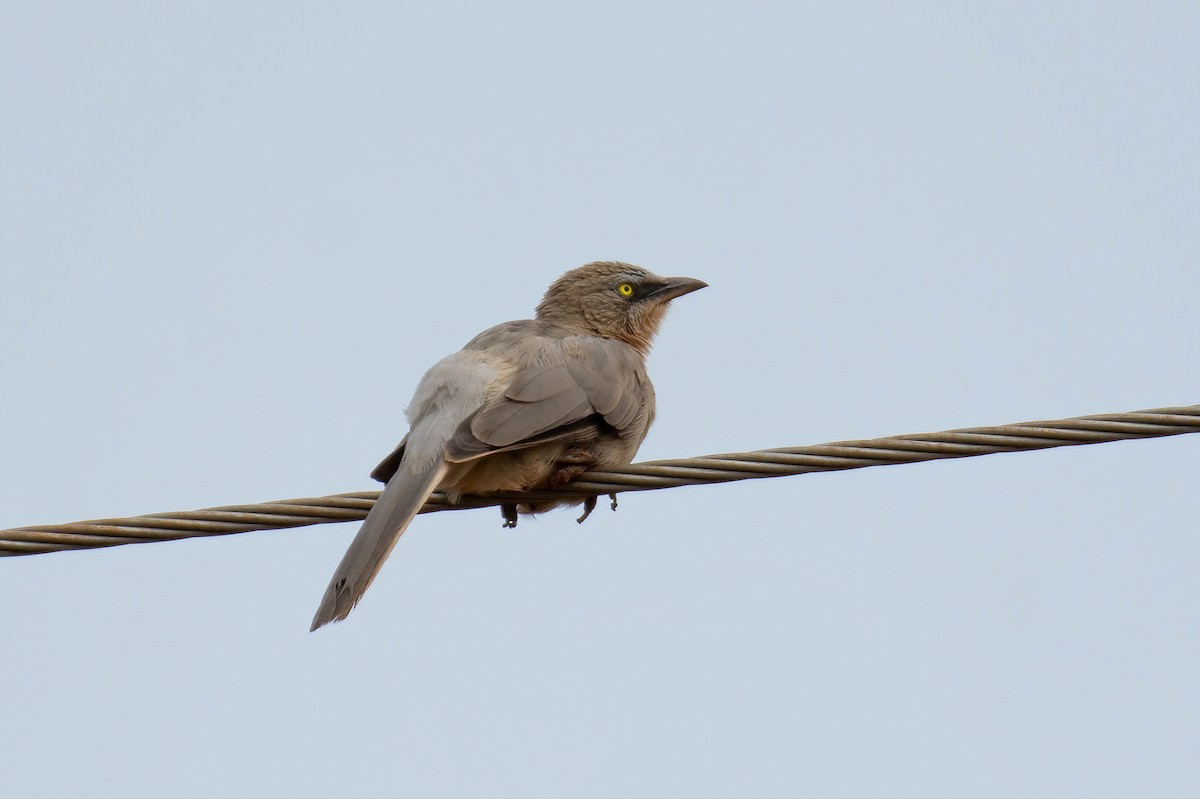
[445,337,648,463]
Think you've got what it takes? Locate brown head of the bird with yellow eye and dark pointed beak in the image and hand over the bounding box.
[538,260,708,355]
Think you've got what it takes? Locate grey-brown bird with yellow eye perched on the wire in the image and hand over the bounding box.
[310,260,708,631]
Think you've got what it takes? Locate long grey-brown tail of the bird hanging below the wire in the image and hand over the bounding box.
[310,458,450,632]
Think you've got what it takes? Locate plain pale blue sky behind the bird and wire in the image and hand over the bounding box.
[0,1,1200,798]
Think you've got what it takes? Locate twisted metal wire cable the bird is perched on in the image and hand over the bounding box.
[0,405,1200,555]
